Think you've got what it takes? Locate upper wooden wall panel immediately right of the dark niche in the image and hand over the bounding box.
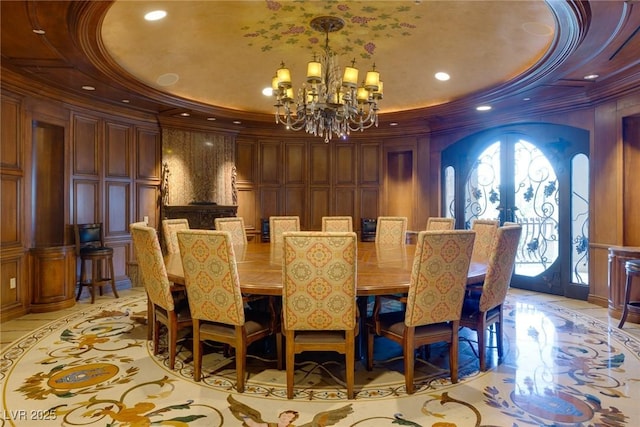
[72,116,101,176]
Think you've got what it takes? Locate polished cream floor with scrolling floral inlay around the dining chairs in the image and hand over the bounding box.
[0,295,640,427]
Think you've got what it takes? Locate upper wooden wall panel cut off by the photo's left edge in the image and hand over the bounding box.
[0,97,23,170]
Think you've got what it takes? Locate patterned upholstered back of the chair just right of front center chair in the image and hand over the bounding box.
[405,230,475,327]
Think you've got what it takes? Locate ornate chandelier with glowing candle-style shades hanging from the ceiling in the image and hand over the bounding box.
[271,16,382,142]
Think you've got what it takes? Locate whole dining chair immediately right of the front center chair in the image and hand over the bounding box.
[367,230,475,394]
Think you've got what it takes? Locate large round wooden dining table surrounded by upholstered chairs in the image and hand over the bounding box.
[165,242,487,296]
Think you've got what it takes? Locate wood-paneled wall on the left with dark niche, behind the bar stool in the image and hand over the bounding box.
[0,87,161,321]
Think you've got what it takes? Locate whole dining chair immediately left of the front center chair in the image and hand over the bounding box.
[177,230,281,393]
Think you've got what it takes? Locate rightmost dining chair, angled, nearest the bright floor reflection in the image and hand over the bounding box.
[460,225,522,371]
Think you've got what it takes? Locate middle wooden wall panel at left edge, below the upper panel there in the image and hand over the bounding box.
[0,175,20,248]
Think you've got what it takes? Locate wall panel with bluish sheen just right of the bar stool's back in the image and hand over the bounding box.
[103,181,134,238]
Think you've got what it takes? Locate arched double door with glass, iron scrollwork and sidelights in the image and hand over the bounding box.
[442,124,589,299]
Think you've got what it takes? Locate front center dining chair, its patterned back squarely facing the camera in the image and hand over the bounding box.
[282,231,358,399]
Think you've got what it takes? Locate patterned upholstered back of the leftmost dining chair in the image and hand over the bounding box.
[131,225,174,311]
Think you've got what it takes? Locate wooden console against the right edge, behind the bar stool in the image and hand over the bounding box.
[609,246,640,323]
